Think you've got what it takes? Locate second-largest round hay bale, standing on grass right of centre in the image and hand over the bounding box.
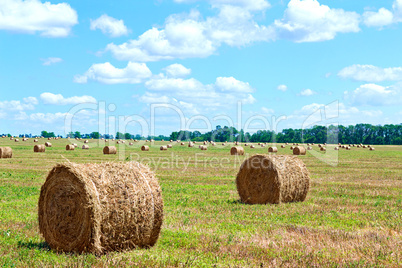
[236,154,310,204]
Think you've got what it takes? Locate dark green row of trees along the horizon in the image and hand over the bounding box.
[2,124,402,145]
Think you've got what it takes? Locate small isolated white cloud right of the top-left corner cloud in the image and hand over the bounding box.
[90,14,128,37]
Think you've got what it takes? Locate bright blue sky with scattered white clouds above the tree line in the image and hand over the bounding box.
[0,0,402,135]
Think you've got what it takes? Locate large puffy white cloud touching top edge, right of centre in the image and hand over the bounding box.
[274,0,360,42]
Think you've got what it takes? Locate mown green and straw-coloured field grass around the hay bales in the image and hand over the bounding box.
[0,139,402,267]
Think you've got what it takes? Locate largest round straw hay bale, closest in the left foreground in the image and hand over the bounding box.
[38,162,163,254]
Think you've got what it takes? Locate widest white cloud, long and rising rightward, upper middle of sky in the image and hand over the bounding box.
[106,4,274,62]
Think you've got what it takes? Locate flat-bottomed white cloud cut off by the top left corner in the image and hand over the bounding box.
[0,0,78,37]
